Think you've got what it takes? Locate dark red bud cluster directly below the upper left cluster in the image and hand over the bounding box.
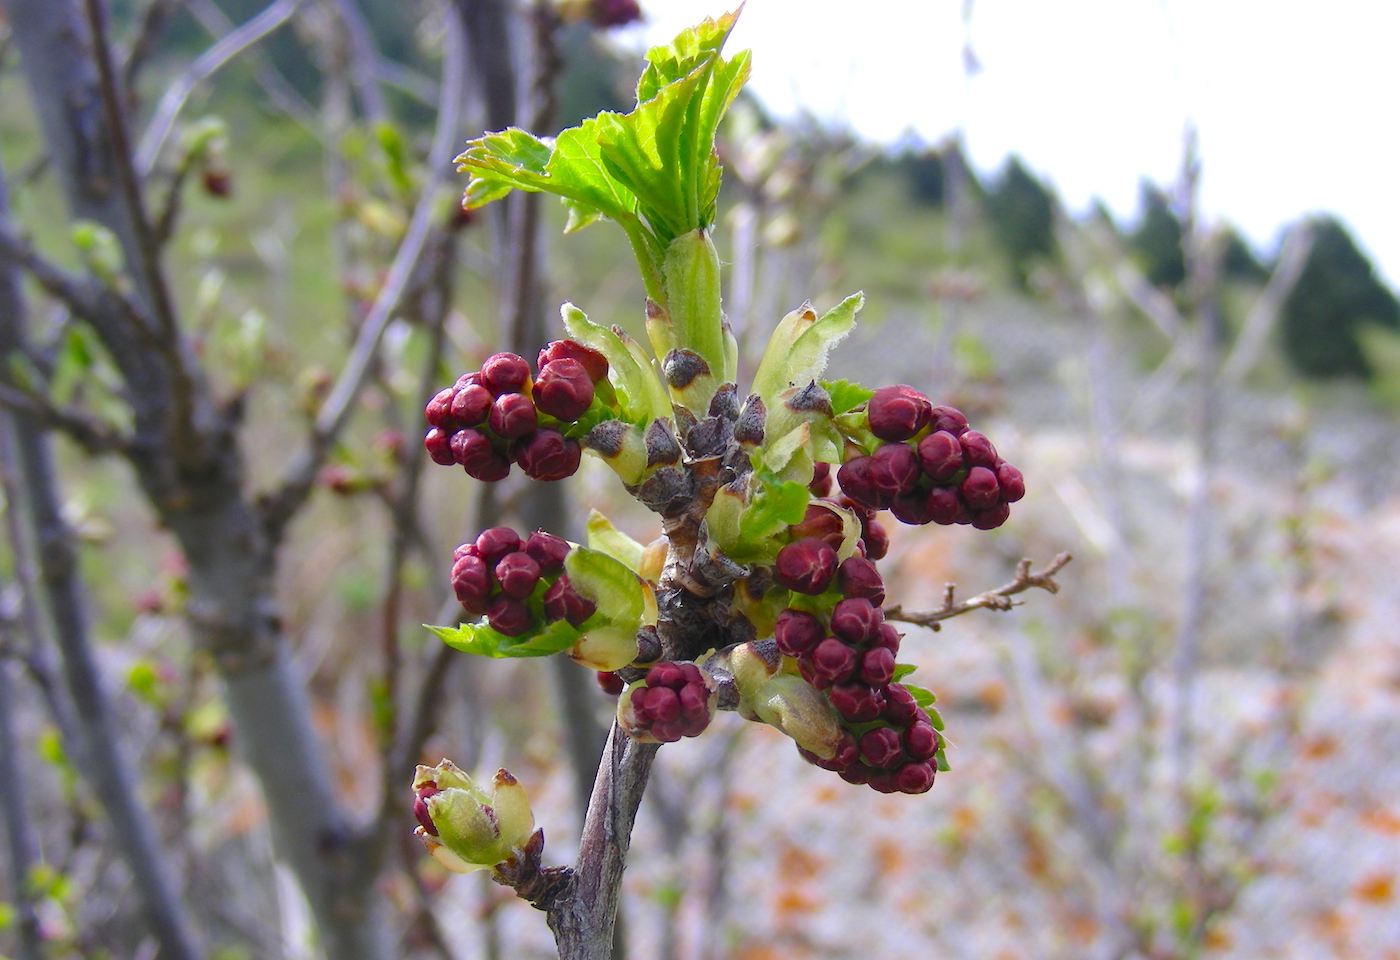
[452,526,595,637]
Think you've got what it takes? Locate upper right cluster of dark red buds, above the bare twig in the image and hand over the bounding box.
[836,385,1026,530]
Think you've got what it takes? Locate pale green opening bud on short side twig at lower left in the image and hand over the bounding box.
[413,760,535,873]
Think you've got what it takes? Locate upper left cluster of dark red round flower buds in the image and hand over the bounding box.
[423,340,608,481]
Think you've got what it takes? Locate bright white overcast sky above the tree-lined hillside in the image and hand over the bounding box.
[630,0,1400,285]
